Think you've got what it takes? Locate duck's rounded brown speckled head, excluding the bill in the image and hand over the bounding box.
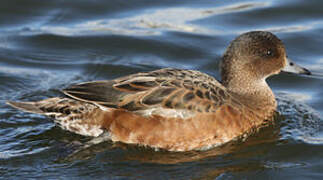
[221,31,286,86]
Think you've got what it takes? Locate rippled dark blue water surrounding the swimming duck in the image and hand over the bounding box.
[0,0,323,179]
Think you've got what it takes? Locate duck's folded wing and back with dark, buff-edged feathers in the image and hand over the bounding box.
[63,68,233,112]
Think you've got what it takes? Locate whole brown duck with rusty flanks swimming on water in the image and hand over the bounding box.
[7,31,311,151]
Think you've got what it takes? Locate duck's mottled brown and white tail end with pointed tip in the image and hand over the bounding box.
[7,97,104,136]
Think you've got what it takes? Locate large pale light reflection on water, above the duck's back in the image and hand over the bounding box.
[13,2,269,36]
